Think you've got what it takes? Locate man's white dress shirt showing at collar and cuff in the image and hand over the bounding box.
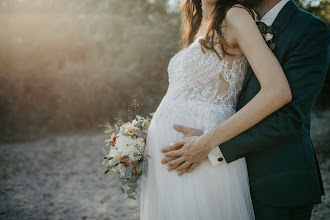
[208,0,290,166]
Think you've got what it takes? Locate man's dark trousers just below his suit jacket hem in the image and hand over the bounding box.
[253,199,313,220]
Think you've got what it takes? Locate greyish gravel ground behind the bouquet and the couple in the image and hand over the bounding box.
[0,111,330,220]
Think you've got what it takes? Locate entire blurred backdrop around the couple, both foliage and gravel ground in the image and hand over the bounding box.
[0,0,330,219]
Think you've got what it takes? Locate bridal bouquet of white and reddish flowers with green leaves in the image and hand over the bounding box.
[100,93,153,200]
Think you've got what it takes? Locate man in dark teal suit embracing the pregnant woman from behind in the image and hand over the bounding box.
[162,0,330,220]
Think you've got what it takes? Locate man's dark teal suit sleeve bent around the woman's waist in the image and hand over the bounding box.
[219,20,330,163]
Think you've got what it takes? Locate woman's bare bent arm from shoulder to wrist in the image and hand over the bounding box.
[204,8,292,150]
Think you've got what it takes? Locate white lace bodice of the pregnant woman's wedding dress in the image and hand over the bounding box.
[154,32,248,132]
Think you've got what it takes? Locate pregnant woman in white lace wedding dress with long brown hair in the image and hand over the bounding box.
[140,0,291,220]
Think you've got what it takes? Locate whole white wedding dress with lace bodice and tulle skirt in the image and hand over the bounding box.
[140,31,254,220]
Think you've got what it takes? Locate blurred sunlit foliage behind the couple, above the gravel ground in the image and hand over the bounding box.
[0,0,330,140]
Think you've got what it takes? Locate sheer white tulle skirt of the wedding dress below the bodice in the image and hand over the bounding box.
[140,112,254,220]
